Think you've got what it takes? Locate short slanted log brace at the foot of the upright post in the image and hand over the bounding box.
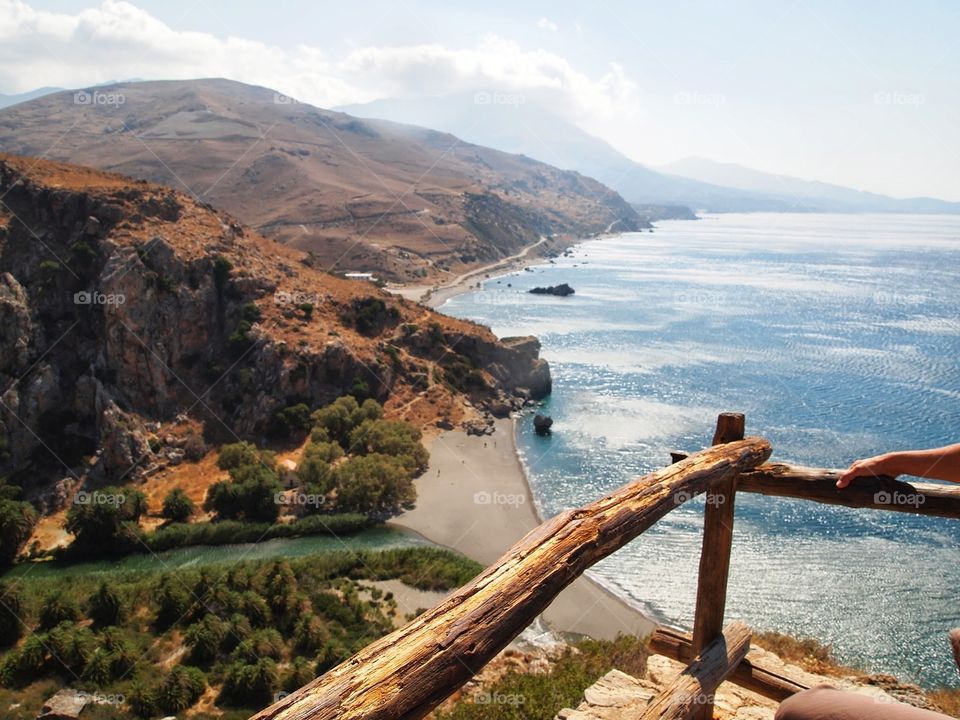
[640,623,750,720]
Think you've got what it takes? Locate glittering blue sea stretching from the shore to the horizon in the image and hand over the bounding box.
[442,214,960,687]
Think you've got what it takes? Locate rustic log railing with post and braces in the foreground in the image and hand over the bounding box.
[251,413,960,720]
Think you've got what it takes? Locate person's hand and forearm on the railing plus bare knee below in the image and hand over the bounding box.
[775,443,960,720]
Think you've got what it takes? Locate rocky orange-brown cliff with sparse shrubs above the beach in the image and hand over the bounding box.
[0,155,550,508]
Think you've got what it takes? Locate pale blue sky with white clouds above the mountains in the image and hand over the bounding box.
[0,0,960,201]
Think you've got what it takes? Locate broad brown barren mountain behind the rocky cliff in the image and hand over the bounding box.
[0,80,644,280]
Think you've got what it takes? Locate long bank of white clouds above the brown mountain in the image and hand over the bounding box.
[0,0,636,117]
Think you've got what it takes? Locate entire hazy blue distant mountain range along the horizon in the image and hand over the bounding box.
[338,93,960,213]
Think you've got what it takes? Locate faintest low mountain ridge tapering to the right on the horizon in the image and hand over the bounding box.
[660,157,960,213]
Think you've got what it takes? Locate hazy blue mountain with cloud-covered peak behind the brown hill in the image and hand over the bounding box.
[338,93,789,212]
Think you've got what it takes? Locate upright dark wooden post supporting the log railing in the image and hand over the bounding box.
[691,413,746,720]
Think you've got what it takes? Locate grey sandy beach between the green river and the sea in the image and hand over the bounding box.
[393,420,655,639]
